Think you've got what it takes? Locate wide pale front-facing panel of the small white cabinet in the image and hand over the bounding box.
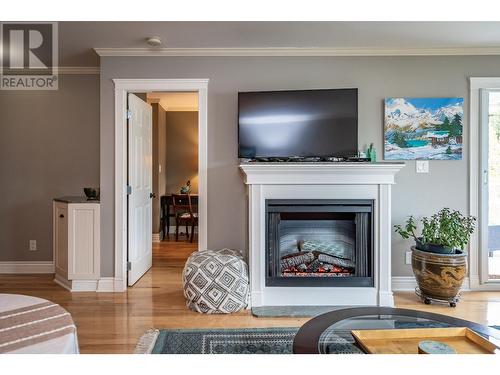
[68,203,100,280]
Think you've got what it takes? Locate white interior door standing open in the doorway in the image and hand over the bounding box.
[128,94,153,286]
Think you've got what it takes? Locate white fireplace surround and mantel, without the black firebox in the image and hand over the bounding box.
[240,163,404,307]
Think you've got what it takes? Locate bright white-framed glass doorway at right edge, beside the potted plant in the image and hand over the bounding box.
[469,77,500,290]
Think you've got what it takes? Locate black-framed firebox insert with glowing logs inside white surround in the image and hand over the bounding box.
[266,199,374,287]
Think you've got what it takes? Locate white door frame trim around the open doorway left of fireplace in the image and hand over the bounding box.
[113,79,209,292]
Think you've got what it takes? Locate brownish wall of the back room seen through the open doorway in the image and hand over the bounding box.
[165,111,198,194]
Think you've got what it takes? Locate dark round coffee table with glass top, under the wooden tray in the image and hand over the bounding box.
[293,307,500,354]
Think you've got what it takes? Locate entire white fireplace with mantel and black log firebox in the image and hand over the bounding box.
[240,163,404,308]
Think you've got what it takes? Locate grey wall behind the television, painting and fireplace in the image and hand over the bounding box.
[101,56,500,276]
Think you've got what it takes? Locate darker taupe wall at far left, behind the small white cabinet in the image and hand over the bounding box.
[0,75,99,261]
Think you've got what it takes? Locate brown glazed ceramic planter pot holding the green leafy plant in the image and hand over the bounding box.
[411,246,467,300]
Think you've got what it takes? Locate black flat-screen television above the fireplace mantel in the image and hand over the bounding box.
[238,89,358,158]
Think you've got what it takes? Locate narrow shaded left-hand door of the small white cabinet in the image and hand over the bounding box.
[53,202,68,278]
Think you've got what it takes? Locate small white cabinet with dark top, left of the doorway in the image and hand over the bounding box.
[53,197,101,291]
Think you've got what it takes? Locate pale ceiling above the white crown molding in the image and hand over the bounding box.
[59,22,500,67]
